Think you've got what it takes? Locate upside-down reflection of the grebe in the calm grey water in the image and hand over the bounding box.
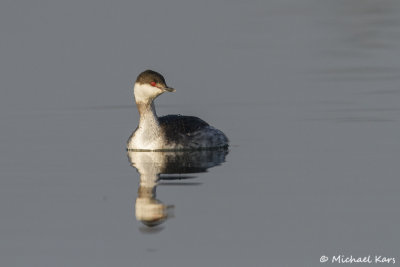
[128,148,228,227]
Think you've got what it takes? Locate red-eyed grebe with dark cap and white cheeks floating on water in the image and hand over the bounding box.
[127,70,229,151]
